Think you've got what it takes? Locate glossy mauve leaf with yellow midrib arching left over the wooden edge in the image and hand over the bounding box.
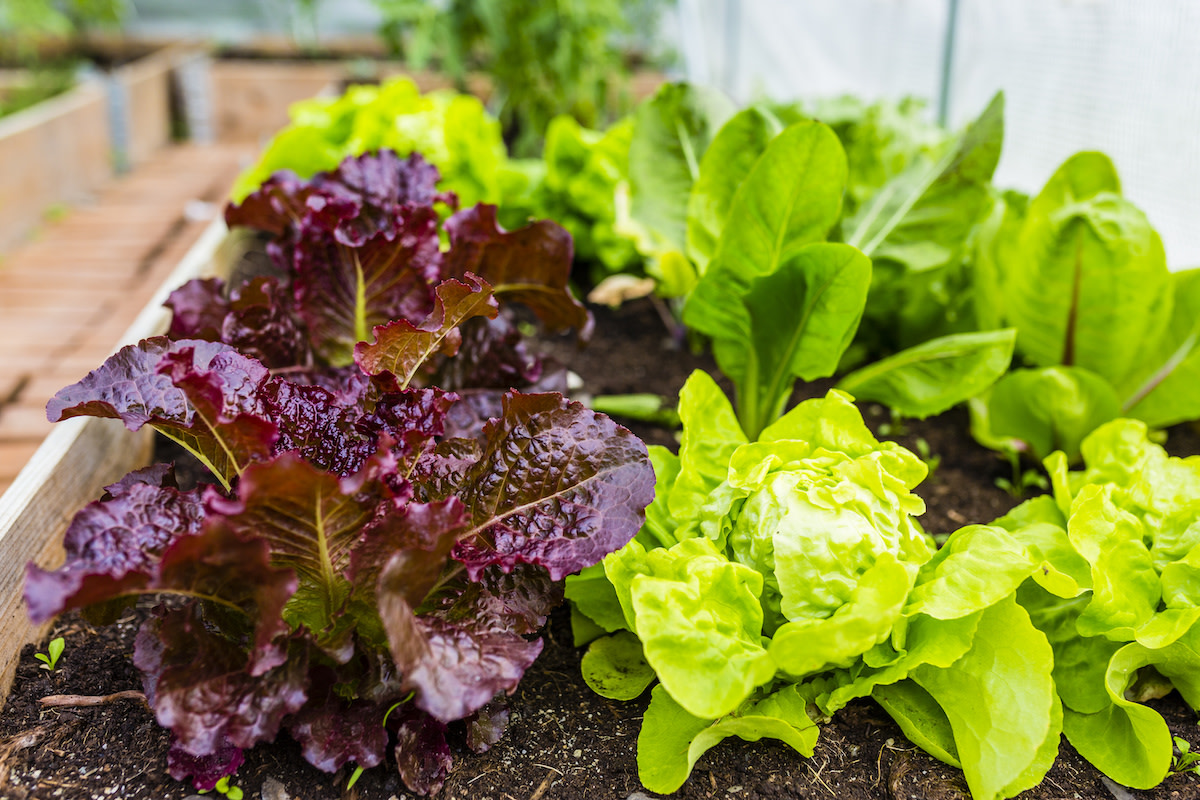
[46,336,276,488]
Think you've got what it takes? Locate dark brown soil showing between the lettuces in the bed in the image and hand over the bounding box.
[0,303,1200,800]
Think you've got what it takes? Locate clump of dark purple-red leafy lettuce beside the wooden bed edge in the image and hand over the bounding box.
[25,152,654,794]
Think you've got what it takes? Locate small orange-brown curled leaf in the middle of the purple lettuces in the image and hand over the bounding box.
[354,275,499,387]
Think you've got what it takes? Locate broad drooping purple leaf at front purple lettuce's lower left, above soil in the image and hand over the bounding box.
[133,603,308,757]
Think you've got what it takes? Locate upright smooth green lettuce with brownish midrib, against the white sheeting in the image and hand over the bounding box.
[972,152,1200,461]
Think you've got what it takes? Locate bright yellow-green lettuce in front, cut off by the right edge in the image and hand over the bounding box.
[1016,419,1200,789]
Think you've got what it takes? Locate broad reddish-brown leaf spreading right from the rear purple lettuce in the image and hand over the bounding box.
[445,204,593,339]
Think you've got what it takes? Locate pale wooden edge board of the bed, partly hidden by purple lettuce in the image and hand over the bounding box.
[0,221,224,694]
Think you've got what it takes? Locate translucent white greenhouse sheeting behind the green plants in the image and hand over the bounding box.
[679,0,1200,269]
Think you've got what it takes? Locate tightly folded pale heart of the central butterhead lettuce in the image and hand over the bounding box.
[727,381,932,638]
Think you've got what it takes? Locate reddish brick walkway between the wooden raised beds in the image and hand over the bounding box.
[0,145,252,492]
